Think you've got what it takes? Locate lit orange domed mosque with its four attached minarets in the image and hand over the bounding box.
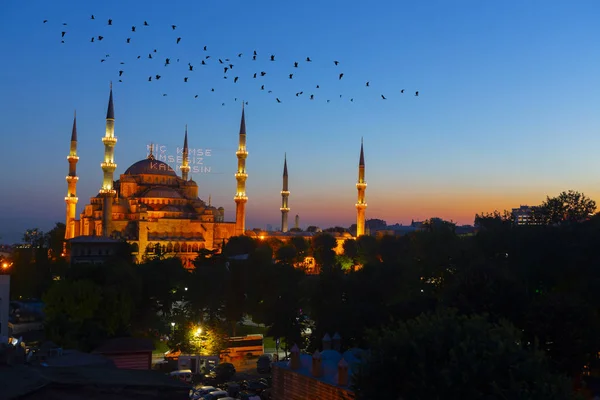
[65,85,248,266]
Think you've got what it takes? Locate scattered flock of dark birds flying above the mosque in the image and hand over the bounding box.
[43,15,419,106]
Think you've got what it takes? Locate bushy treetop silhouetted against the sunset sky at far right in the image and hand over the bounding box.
[533,190,596,225]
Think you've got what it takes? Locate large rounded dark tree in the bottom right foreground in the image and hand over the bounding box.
[353,310,573,400]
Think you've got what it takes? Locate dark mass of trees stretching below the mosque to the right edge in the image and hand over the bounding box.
[8,191,600,399]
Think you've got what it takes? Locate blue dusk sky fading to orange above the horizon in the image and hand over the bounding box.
[0,0,600,243]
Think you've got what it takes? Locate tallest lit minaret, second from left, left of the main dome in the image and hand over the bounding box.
[100,82,117,236]
